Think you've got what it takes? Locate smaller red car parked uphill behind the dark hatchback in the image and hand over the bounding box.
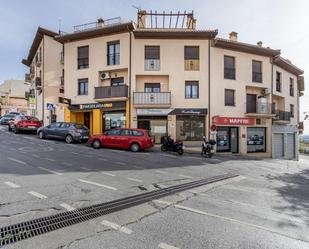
[11,115,42,134]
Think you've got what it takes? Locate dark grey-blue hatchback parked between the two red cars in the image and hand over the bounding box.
[37,122,90,144]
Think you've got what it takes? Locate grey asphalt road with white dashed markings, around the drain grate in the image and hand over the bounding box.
[0,127,309,249]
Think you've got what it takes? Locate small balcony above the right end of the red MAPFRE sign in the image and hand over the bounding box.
[245,102,276,117]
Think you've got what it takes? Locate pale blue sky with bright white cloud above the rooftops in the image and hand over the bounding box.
[0,0,309,134]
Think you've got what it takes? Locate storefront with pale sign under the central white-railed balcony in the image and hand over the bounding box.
[137,109,171,143]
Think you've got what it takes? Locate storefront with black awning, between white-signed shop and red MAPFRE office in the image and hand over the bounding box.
[169,108,207,141]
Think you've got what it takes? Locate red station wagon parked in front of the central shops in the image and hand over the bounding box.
[88,129,153,152]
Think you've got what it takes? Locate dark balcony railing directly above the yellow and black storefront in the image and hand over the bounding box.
[94,85,128,99]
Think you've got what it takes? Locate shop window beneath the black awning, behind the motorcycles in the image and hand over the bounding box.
[176,115,205,141]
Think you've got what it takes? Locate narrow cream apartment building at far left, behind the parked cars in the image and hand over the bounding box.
[22,27,64,125]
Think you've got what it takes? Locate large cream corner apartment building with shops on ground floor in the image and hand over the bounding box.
[55,11,304,158]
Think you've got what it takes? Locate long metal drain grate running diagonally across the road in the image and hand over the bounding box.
[0,174,238,247]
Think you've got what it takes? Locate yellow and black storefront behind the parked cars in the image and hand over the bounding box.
[65,101,128,134]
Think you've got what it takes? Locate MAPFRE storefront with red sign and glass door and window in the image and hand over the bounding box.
[212,116,271,156]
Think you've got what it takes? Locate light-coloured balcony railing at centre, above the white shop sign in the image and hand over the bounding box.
[133,92,171,105]
